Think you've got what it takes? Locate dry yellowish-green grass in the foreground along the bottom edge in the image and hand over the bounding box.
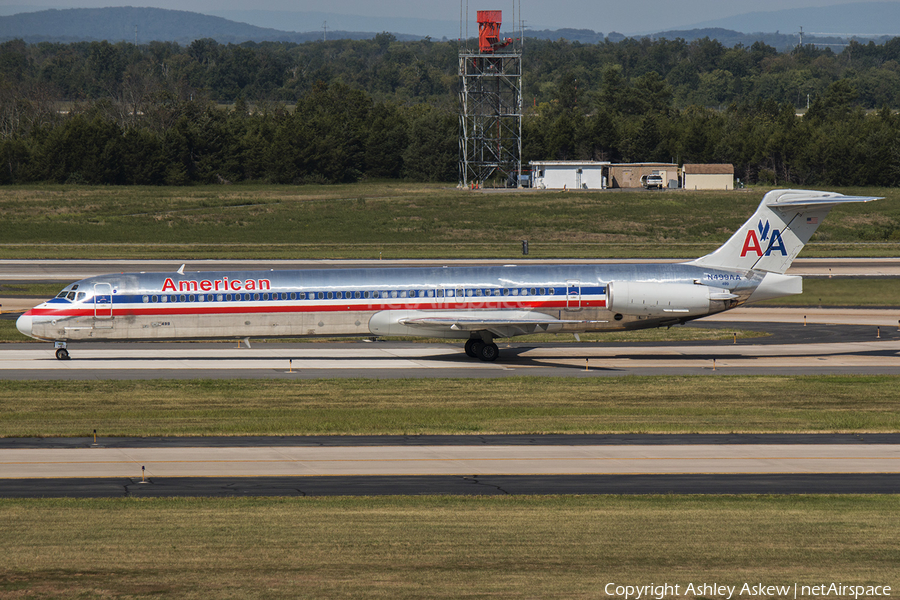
[0,496,900,599]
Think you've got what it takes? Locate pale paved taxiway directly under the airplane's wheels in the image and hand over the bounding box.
[0,311,900,380]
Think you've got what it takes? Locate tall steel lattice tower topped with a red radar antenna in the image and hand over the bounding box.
[459,10,523,187]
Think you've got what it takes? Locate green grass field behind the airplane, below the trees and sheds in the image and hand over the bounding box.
[0,183,900,260]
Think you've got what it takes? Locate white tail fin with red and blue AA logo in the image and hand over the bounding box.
[688,190,880,274]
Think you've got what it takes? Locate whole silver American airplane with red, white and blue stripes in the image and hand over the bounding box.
[16,190,878,361]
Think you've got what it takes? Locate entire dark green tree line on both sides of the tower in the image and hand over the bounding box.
[0,34,900,185]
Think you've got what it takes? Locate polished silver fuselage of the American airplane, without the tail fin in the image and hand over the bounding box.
[19,264,763,341]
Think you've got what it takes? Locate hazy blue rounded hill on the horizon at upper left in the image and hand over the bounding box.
[0,7,419,44]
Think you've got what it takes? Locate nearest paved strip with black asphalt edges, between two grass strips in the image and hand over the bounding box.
[0,434,900,498]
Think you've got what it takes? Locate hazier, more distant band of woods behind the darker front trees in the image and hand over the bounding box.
[0,33,900,109]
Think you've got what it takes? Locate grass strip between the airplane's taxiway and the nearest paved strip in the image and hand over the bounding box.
[0,376,900,437]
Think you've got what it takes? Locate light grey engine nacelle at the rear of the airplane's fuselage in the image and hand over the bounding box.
[607,281,721,317]
